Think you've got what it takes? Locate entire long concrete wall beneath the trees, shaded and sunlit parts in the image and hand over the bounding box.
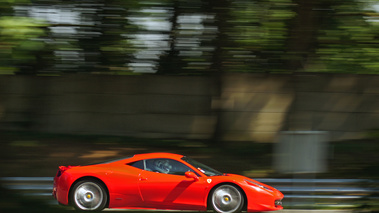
[0,74,379,142]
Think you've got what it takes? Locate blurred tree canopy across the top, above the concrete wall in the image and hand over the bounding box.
[0,0,379,75]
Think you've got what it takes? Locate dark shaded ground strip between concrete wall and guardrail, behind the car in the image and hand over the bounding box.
[0,132,379,179]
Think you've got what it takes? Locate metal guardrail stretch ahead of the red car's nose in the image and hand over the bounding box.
[256,179,379,208]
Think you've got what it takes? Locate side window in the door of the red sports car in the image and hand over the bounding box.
[146,158,193,175]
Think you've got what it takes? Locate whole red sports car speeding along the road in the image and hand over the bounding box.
[53,153,283,213]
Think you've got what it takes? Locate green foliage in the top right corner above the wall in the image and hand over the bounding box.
[308,0,379,74]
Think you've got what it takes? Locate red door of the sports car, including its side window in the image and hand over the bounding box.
[139,158,206,210]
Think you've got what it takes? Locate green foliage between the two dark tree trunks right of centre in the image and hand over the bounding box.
[227,0,296,72]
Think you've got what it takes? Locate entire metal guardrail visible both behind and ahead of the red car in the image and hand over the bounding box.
[0,177,379,208]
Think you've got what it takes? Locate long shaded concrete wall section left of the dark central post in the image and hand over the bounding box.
[0,75,212,138]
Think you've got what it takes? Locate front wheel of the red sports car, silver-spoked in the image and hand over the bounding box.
[209,184,245,213]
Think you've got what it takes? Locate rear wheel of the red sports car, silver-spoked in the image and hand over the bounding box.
[70,180,108,211]
